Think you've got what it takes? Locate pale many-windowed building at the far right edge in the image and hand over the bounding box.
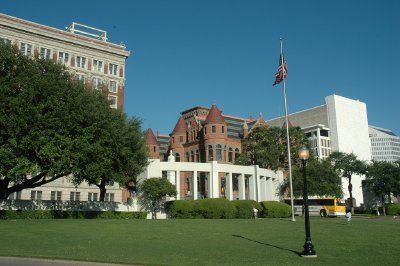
[369,125,400,162]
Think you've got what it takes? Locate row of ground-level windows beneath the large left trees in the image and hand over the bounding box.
[8,190,115,202]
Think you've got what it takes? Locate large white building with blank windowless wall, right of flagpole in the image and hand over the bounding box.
[267,95,372,206]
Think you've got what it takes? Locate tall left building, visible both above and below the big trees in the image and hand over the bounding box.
[0,13,130,202]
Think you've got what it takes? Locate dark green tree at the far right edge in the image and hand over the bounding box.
[365,161,400,215]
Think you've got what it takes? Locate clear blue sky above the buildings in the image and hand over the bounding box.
[0,0,400,134]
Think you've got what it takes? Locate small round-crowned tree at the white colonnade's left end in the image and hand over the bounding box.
[139,177,176,219]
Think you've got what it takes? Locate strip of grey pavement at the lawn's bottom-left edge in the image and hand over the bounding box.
[0,257,133,266]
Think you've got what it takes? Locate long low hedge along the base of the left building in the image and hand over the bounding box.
[0,210,147,220]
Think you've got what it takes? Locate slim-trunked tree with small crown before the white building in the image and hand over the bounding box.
[328,152,366,214]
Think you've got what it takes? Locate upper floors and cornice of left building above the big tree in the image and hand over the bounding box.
[0,13,130,109]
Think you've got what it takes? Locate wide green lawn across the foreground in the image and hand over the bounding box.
[0,217,400,265]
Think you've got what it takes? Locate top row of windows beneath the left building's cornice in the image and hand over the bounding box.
[0,37,122,76]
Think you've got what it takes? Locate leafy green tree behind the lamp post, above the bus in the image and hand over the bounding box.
[281,157,342,198]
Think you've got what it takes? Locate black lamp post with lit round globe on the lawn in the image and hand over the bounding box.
[299,147,317,258]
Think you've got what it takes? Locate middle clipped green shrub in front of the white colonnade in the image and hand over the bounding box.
[194,199,236,219]
